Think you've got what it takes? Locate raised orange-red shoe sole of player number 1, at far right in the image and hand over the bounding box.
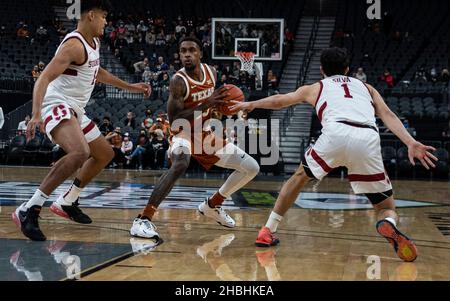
[377,220,418,262]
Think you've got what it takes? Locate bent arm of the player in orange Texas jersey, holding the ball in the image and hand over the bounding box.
[167,76,228,123]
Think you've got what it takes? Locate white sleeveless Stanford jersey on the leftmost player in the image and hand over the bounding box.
[43,31,100,115]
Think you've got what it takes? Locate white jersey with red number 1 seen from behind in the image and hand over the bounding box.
[316,75,376,128]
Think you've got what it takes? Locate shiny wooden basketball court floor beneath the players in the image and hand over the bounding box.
[0,168,450,281]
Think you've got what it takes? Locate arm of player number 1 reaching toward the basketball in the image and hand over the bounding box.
[230,85,314,113]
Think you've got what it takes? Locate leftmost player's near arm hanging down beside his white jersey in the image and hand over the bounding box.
[27,39,86,140]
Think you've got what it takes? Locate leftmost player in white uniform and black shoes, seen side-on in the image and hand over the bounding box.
[13,0,151,241]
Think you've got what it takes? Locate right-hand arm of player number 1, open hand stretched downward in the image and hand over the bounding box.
[367,85,438,169]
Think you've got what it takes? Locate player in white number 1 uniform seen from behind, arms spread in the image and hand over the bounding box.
[232,48,437,262]
